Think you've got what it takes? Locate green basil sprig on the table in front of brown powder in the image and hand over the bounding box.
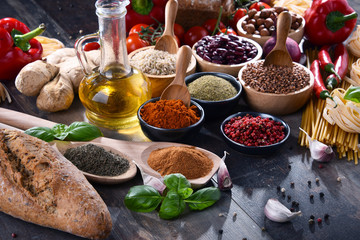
[124,173,221,219]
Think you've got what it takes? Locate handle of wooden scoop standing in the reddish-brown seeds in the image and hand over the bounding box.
[274,11,291,49]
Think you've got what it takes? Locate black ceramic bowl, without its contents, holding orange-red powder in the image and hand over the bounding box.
[137,98,205,142]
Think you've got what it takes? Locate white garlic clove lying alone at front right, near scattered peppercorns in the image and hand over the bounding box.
[264,198,301,222]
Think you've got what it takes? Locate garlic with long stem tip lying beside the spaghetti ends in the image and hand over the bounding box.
[299,128,335,162]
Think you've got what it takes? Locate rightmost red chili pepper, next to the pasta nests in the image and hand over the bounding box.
[326,43,349,90]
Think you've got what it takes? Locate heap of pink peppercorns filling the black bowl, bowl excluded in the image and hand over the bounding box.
[224,114,285,146]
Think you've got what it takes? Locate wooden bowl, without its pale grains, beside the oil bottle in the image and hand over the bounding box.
[129,46,196,98]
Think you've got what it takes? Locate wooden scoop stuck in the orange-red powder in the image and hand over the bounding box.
[160,45,192,107]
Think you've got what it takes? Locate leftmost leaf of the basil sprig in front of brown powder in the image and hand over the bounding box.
[124,185,162,212]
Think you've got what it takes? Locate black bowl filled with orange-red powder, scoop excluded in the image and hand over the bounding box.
[137,98,205,142]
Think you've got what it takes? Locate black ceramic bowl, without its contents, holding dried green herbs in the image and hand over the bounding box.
[185,72,242,118]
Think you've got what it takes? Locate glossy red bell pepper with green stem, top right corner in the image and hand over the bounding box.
[304,0,357,45]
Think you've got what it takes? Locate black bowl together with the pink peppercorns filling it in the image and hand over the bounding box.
[220,112,290,155]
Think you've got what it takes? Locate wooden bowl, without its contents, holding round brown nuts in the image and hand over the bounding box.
[236,15,305,47]
